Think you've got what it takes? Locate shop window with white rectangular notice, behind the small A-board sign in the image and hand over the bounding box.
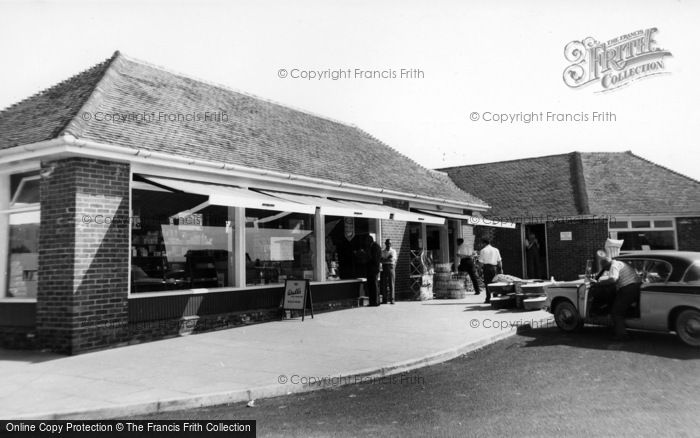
[245,208,316,285]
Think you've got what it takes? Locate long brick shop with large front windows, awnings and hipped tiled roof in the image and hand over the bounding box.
[0,52,504,354]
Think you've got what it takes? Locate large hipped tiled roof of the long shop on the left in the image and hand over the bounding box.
[0,52,484,205]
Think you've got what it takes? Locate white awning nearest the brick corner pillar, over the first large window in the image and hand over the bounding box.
[143,176,316,214]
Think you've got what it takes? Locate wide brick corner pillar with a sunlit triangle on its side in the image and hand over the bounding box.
[36,158,130,354]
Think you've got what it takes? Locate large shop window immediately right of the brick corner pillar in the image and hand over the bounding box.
[131,190,234,293]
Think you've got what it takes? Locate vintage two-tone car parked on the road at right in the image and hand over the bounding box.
[545,251,700,347]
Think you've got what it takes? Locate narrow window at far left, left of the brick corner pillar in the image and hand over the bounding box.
[5,171,40,298]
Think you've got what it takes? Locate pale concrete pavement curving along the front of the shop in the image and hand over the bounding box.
[0,295,553,419]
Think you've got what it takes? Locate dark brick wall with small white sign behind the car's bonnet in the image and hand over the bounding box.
[547,220,608,280]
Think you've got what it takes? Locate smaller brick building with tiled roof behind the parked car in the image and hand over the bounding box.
[441,151,700,279]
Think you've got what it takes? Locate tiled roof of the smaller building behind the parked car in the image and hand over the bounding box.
[442,151,700,217]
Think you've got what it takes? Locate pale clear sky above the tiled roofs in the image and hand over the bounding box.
[0,0,700,180]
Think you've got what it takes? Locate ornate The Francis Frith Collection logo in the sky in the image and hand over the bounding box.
[564,27,672,92]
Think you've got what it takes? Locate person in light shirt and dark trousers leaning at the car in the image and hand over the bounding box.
[595,256,642,341]
